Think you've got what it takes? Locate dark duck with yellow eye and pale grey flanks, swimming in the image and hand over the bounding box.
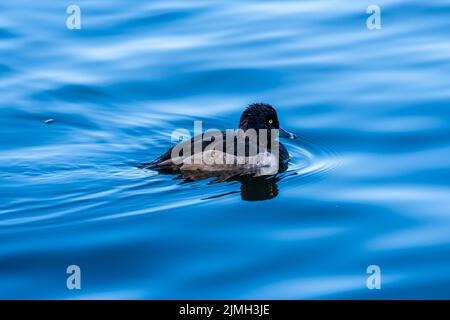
[139,103,297,181]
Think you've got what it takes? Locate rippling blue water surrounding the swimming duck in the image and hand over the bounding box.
[0,0,450,299]
